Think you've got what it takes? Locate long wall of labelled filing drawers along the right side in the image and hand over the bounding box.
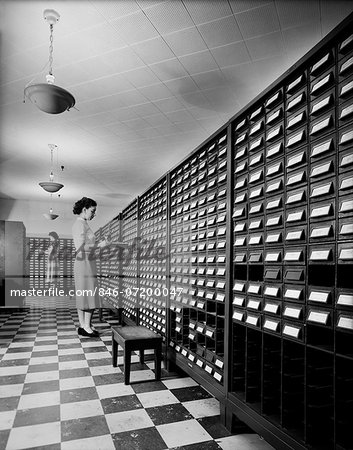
[95,16,353,450]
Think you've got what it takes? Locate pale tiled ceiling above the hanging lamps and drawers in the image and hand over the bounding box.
[0,0,353,212]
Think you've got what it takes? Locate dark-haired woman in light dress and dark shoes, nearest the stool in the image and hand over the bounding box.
[72,197,110,337]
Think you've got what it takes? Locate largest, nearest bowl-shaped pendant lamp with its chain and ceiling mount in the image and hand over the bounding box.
[24,9,75,114]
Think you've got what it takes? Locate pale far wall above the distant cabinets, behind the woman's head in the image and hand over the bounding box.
[0,199,118,238]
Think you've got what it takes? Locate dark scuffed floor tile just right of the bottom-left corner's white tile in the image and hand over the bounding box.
[61,416,110,442]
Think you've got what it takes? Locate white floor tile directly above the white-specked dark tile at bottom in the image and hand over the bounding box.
[105,409,154,433]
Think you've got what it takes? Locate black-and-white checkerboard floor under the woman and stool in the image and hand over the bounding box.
[0,303,272,450]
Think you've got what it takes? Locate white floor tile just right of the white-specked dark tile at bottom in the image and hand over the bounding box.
[157,420,212,447]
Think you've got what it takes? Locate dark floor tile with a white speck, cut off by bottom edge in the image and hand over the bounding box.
[112,428,167,450]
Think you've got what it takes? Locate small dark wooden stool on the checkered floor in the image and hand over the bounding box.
[112,326,162,384]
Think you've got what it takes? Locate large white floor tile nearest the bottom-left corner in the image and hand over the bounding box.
[6,422,61,450]
